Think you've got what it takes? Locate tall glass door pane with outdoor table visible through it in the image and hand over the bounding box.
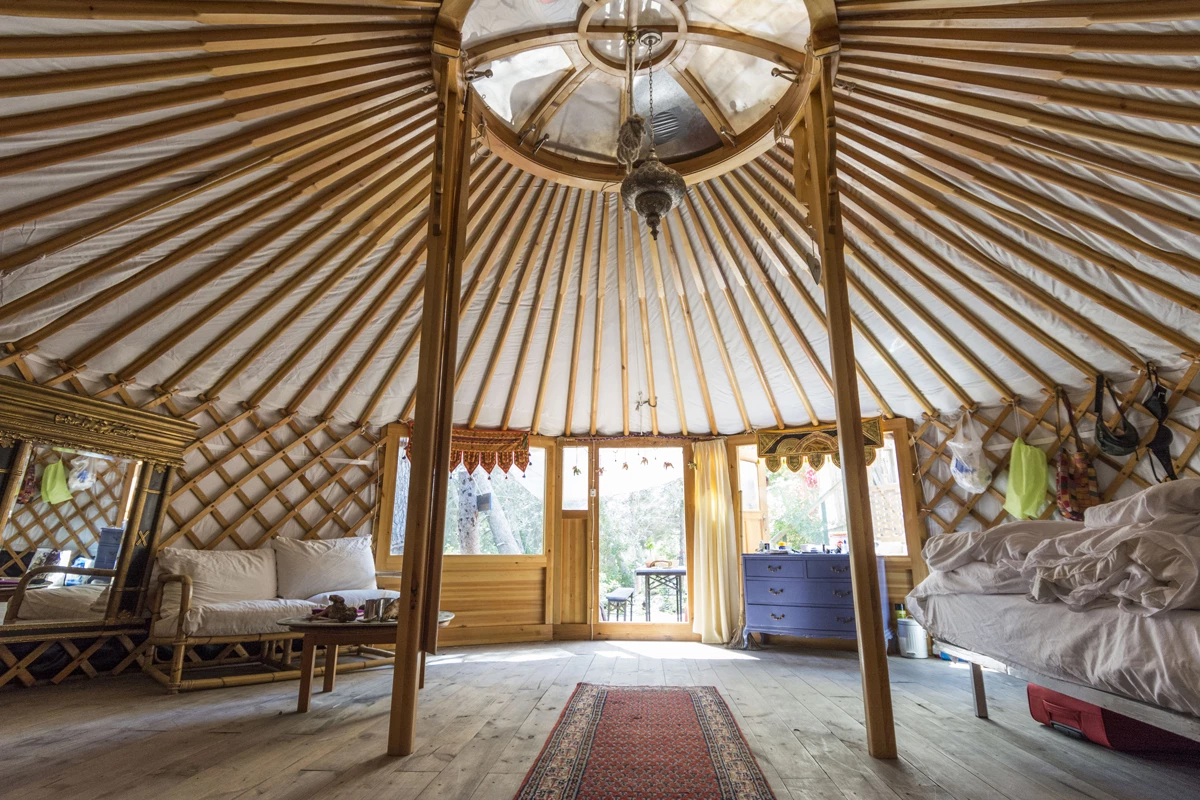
[597,447,688,622]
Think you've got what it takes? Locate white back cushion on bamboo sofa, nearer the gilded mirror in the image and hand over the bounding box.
[156,547,278,616]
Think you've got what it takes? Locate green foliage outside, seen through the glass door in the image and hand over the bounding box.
[600,477,688,620]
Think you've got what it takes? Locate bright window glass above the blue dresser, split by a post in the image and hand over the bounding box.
[758,434,908,555]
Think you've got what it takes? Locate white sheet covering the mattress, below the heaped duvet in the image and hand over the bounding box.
[908,585,1200,716]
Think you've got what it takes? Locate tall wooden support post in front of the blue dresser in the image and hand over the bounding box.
[796,47,896,758]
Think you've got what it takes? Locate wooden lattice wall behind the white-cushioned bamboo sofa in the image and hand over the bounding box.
[2,355,379,549]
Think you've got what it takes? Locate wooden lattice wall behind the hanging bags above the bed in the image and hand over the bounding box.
[916,362,1200,535]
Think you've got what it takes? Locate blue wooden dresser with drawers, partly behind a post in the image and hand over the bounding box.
[742,553,892,648]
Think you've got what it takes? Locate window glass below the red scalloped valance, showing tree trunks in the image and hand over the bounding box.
[443,447,546,555]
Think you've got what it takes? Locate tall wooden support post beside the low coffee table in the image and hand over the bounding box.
[388,37,470,756]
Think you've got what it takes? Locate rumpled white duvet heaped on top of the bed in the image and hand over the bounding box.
[914,479,1200,616]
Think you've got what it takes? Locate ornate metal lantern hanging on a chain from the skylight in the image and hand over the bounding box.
[617,29,686,240]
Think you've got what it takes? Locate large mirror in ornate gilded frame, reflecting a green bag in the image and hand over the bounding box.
[0,378,196,643]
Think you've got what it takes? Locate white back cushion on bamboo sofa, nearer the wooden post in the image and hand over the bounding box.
[271,536,376,600]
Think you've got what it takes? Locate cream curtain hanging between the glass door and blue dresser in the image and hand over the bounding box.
[691,439,742,644]
